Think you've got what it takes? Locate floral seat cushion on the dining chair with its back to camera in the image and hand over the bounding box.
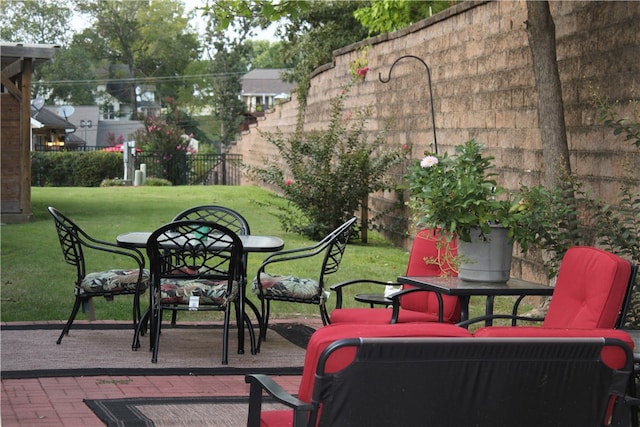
[160,278,238,305]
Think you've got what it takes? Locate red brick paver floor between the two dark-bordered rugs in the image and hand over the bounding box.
[0,321,321,427]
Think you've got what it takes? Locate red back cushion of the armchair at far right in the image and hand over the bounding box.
[543,246,631,329]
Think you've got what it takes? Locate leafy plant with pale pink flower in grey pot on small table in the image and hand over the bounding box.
[406,139,535,282]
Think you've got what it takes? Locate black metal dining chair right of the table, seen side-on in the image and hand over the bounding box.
[252,217,356,347]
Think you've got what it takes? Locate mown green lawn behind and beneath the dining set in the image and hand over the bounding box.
[0,186,528,322]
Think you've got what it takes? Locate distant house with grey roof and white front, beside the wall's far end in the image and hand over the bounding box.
[241,68,296,113]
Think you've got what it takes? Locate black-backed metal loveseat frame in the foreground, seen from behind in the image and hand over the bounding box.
[245,338,633,427]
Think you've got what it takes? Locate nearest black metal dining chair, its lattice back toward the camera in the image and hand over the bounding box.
[147,220,256,364]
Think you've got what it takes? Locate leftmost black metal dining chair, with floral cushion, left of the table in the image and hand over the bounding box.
[48,207,149,344]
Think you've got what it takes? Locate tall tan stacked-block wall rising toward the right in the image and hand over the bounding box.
[233,1,640,282]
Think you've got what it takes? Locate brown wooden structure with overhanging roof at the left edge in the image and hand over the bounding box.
[0,43,57,223]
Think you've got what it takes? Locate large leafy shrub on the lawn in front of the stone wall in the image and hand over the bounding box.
[247,82,407,239]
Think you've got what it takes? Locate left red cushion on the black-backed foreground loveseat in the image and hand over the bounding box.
[260,322,472,427]
